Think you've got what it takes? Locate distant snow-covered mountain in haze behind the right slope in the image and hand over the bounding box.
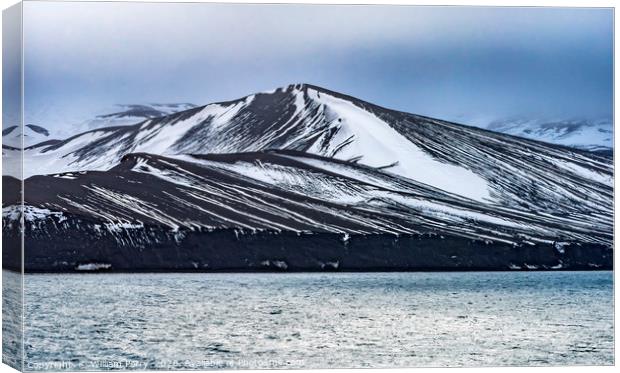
[486,118,613,154]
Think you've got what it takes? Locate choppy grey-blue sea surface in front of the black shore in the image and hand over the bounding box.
[3,271,614,370]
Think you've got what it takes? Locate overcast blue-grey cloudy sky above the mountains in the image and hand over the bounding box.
[24,2,613,131]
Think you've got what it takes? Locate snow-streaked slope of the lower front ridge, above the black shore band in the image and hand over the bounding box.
[8,151,611,244]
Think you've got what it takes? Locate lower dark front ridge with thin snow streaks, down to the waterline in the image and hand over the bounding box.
[3,151,613,272]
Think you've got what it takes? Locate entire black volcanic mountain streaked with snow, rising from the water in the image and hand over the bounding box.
[3,85,613,271]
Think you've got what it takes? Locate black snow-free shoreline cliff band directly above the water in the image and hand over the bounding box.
[2,220,614,273]
